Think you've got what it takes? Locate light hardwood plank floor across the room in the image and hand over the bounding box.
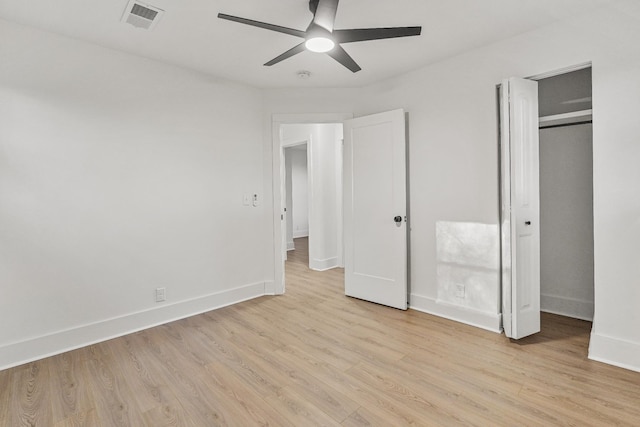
[0,239,640,427]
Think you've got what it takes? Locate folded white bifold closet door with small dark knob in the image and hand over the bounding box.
[500,78,540,339]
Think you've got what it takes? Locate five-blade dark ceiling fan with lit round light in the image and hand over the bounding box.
[218,0,422,73]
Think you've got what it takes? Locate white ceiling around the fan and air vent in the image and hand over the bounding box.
[0,0,615,88]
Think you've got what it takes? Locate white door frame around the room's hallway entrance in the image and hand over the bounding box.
[265,113,353,295]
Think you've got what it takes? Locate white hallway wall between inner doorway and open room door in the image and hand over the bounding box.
[282,124,342,270]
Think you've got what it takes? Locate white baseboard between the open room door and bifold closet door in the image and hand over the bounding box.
[409,294,502,333]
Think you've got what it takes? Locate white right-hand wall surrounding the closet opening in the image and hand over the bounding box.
[356,1,640,370]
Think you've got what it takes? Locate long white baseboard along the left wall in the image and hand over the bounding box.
[0,282,266,370]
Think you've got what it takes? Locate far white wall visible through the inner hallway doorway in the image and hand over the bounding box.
[290,149,309,238]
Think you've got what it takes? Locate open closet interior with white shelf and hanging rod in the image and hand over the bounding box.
[538,67,594,320]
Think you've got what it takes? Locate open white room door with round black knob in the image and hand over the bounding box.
[344,110,407,310]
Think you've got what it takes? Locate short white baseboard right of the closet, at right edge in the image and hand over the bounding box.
[589,331,640,372]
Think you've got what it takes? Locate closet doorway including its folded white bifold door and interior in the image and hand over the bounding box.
[500,65,594,339]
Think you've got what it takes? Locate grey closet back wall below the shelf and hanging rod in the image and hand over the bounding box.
[540,124,594,320]
